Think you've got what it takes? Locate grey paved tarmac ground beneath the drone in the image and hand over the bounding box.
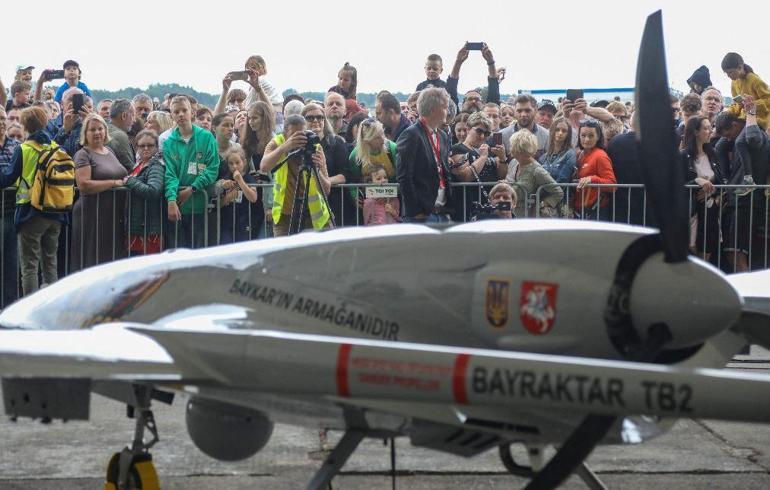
[0,362,770,490]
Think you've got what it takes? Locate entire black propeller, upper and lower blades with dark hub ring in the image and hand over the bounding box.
[526,10,688,490]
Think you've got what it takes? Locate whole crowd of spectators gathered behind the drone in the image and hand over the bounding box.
[0,44,770,304]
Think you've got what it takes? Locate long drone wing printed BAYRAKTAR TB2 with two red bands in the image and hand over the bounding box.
[0,324,770,422]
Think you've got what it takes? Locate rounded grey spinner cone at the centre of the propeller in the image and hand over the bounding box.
[630,254,742,348]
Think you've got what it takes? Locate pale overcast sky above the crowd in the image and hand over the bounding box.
[0,0,770,98]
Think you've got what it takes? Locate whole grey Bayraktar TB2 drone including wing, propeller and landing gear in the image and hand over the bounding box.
[0,12,770,489]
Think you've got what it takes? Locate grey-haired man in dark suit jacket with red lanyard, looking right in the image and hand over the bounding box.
[396,88,451,223]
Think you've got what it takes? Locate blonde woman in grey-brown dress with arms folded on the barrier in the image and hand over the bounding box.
[70,112,127,272]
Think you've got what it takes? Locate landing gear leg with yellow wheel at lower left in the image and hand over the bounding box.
[104,386,160,490]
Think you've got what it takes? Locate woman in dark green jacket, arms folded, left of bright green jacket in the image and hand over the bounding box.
[125,129,166,255]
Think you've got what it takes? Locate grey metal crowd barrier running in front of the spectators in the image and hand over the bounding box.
[0,182,770,307]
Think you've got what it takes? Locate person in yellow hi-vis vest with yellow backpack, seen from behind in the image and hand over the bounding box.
[0,107,75,296]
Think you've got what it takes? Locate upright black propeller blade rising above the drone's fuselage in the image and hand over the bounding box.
[636,10,688,262]
